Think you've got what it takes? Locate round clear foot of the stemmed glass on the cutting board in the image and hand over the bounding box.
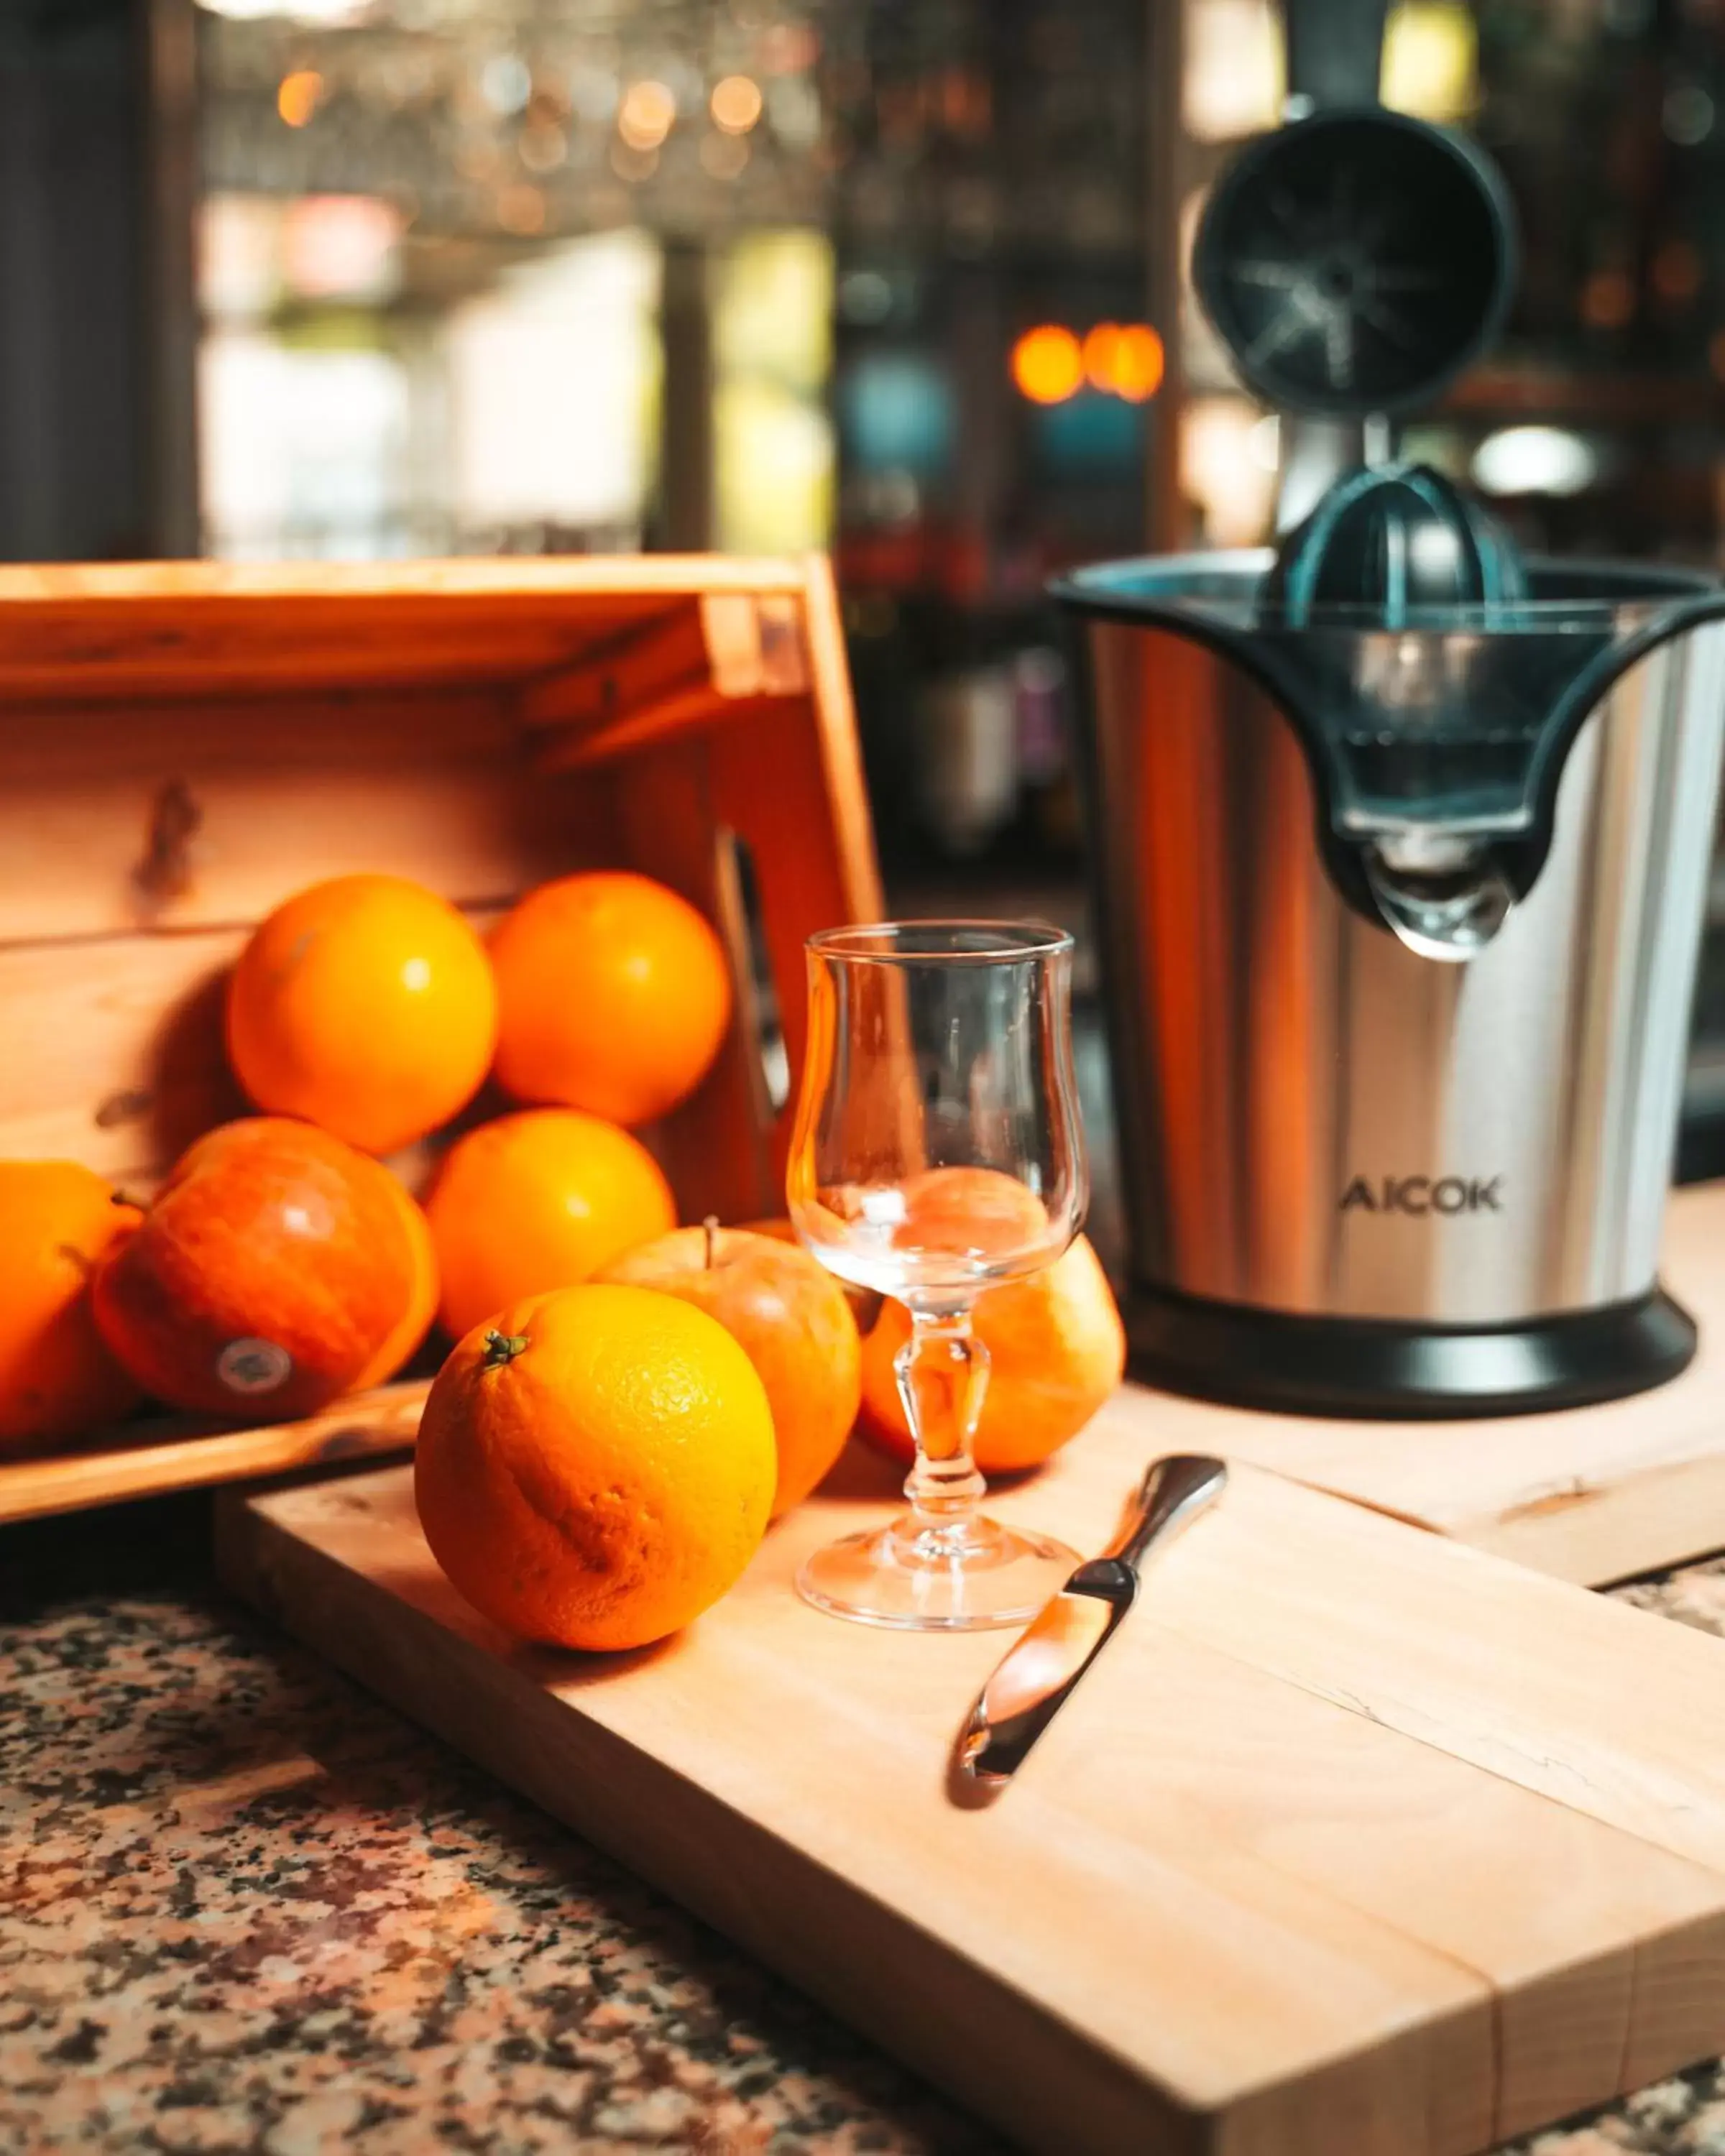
[796,1514,1080,1632]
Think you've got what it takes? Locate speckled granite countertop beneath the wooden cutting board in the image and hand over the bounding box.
[0,1498,1725,2156]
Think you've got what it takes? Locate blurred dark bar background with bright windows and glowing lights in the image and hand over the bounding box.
[17,0,1725,1169]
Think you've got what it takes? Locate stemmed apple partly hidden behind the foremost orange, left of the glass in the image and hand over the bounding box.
[602,1220,862,1520]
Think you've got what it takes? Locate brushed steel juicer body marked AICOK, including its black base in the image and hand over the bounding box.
[1061,554,1725,1414]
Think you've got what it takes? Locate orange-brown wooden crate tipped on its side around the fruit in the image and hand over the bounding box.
[0,556,880,1520]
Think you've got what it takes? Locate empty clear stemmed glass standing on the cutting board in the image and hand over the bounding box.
[787,921,1089,1630]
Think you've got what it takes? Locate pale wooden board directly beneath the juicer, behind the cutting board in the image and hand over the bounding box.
[1154,1184,1725,1587]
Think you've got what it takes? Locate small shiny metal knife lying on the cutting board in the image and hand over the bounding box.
[957,1453,1227,1789]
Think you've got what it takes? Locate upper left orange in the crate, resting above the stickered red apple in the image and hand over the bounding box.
[226,875,498,1153]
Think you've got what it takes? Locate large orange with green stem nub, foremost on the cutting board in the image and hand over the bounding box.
[414,1287,776,1647]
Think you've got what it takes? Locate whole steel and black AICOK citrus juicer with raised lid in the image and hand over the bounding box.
[1057,4,1725,1414]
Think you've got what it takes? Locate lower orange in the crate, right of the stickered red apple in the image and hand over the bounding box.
[425,1108,677,1339]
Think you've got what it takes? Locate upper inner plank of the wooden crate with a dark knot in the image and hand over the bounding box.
[0,690,615,944]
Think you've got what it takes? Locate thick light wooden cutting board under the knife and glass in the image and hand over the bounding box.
[220,1399,1725,2156]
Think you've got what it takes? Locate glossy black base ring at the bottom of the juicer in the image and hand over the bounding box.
[1126,1287,1697,1421]
